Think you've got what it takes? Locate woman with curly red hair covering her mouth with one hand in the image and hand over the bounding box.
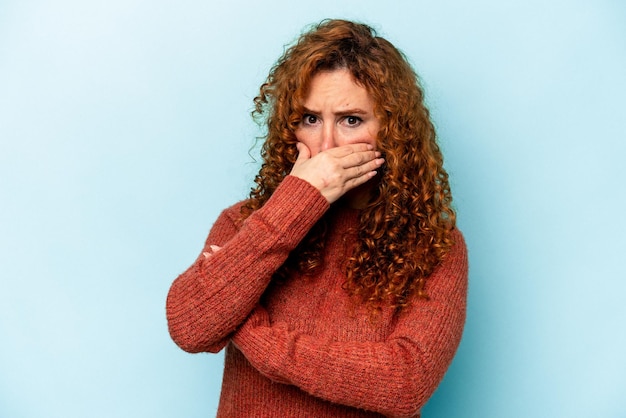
[167,20,467,417]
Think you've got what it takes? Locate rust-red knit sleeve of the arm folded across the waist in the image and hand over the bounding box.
[233,232,468,417]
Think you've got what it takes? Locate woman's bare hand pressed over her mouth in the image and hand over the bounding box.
[290,142,385,203]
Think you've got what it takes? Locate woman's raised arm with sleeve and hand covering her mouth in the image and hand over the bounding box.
[166,143,383,352]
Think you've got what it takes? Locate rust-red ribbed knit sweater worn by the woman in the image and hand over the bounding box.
[167,176,467,418]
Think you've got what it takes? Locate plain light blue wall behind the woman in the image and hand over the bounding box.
[0,0,626,418]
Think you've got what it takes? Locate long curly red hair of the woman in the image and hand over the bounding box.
[241,20,456,309]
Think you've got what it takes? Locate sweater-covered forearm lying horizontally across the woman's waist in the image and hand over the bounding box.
[233,310,462,416]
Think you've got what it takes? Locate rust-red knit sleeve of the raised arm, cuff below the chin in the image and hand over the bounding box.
[166,176,329,352]
